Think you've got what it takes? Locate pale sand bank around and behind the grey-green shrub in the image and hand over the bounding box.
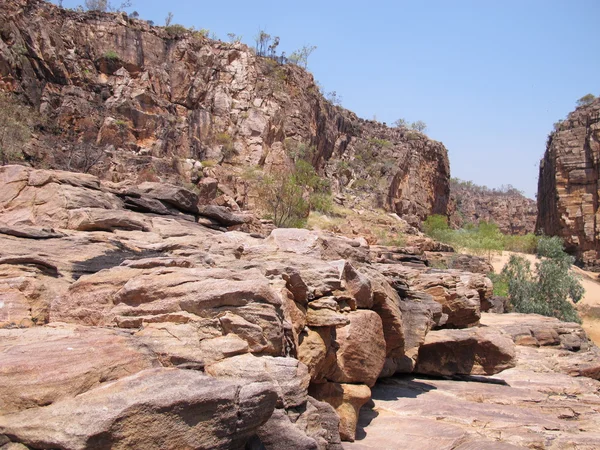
[492,252,600,346]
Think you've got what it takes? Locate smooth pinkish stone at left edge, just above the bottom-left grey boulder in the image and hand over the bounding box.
[0,325,159,414]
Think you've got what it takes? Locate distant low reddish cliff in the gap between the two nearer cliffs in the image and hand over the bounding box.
[448,179,537,234]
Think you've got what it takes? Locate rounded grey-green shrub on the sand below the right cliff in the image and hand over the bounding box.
[502,237,584,323]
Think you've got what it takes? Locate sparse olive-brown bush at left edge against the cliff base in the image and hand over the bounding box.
[0,94,35,166]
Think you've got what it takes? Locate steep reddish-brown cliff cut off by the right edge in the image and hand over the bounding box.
[536,99,600,270]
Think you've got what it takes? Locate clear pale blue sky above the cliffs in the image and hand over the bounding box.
[55,0,600,198]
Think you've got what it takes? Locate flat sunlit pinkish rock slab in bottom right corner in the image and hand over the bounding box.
[344,368,600,450]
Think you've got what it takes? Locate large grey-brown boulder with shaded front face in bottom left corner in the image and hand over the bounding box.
[0,369,277,449]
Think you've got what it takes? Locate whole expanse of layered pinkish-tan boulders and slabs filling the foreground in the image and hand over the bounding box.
[0,166,600,450]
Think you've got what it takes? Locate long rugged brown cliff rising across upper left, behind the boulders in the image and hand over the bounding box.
[0,0,449,219]
